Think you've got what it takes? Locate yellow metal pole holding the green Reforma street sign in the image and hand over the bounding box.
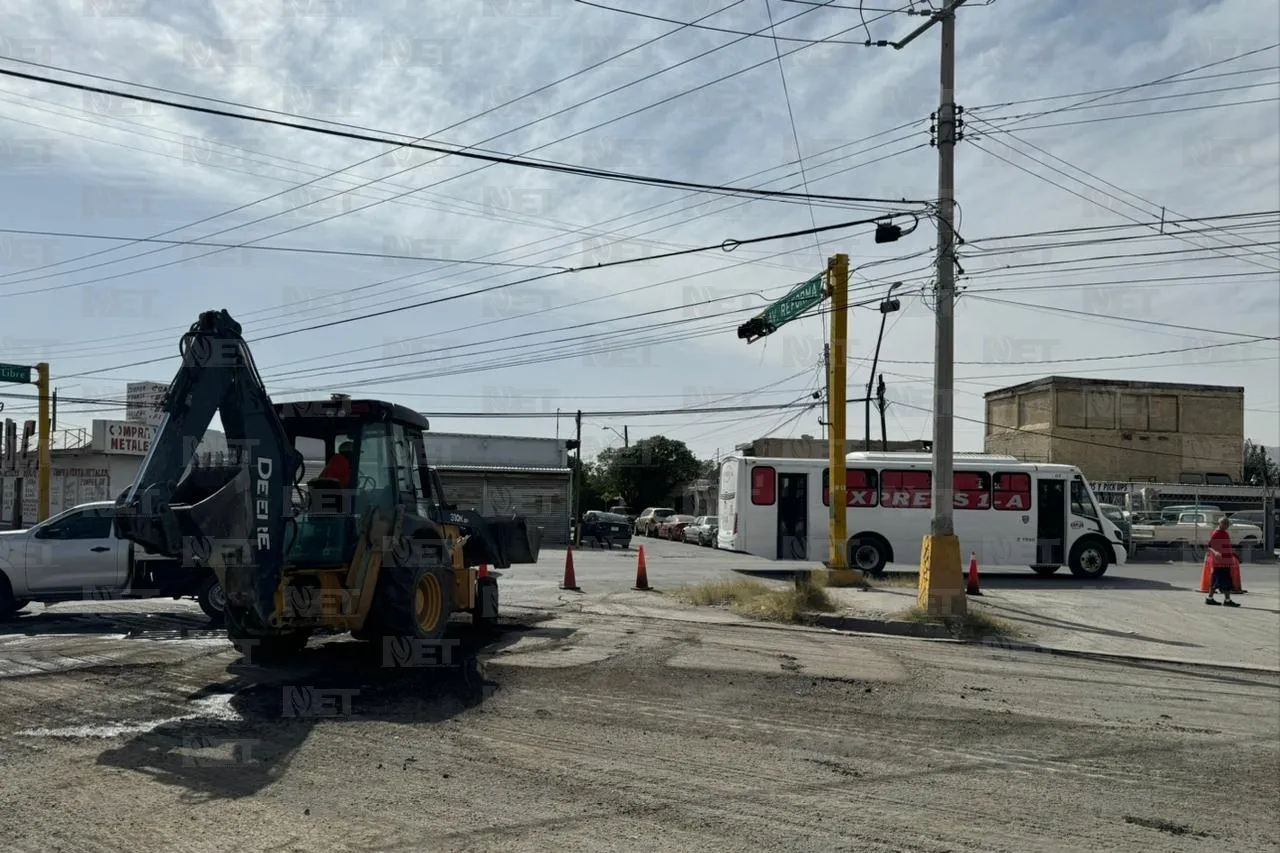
[827,255,864,587]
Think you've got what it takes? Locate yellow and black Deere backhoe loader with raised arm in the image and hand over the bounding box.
[115,310,541,661]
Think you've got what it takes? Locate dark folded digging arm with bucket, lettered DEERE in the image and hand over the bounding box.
[115,310,302,625]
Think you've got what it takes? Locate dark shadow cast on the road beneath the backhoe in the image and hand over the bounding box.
[97,621,560,802]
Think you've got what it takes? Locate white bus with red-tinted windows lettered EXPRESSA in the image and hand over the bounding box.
[716,452,1128,578]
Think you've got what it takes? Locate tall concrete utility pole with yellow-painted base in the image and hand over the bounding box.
[918,0,968,616]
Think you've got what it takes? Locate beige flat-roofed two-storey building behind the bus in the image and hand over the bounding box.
[984,377,1244,484]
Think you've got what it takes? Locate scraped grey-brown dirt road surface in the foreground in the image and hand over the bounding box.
[0,601,1280,853]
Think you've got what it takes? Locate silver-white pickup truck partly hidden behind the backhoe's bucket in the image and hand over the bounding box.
[0,501,225,621]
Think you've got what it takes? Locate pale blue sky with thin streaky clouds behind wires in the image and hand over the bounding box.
[0,0,1280,466]
